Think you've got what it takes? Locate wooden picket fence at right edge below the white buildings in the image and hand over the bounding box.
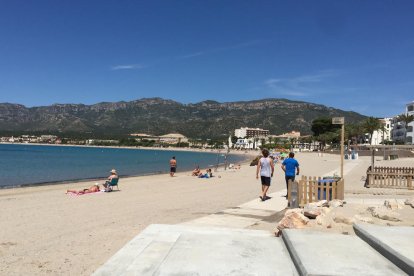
[366,167,414,190]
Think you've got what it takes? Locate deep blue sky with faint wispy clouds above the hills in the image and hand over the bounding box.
[0,0,414,117]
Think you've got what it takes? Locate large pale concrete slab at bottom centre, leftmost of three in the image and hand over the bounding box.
[93,225,297,275]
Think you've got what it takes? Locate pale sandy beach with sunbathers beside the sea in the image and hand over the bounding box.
[0,153,412,275]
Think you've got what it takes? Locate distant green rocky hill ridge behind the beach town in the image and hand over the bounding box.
[0,98,366,138]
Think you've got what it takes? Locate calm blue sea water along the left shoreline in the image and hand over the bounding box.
[0,144,243,188]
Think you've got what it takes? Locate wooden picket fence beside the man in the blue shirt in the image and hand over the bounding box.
[288,176,344,207]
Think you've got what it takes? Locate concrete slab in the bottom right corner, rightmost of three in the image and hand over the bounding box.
[354,224,414,275]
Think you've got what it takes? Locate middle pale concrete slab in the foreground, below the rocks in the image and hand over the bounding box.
[282,229,405,275]
